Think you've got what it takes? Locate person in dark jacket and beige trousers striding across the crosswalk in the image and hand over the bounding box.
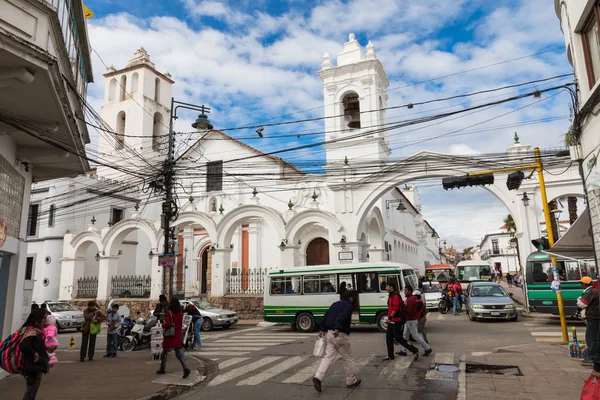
[313,290,361,392]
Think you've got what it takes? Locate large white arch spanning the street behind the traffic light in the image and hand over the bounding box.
[356,151,520,237]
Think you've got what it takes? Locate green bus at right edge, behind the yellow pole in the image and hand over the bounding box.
[525,251,598,316]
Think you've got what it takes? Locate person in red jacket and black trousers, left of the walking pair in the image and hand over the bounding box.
[383,282,419,361]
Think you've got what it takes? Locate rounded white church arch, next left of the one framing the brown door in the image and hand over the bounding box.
[216,205,285,248]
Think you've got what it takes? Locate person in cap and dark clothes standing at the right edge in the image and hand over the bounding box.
[577,276,600,364]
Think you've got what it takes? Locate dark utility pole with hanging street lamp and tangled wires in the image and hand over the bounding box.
[162,98,213,299]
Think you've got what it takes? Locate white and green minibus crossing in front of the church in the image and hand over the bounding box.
[264,262,418,332]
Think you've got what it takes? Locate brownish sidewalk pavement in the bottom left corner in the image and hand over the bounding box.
[0,346,204,400]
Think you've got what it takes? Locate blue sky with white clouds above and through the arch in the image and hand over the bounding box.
[85,0,572,248]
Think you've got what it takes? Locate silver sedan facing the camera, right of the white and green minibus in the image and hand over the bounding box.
[466,282,519,321]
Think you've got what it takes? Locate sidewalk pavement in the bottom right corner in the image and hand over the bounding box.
[466,343,592,400]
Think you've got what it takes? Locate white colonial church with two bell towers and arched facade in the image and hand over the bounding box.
[27,35,450,301]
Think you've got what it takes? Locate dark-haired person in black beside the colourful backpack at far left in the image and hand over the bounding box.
[19,308,49,400]
